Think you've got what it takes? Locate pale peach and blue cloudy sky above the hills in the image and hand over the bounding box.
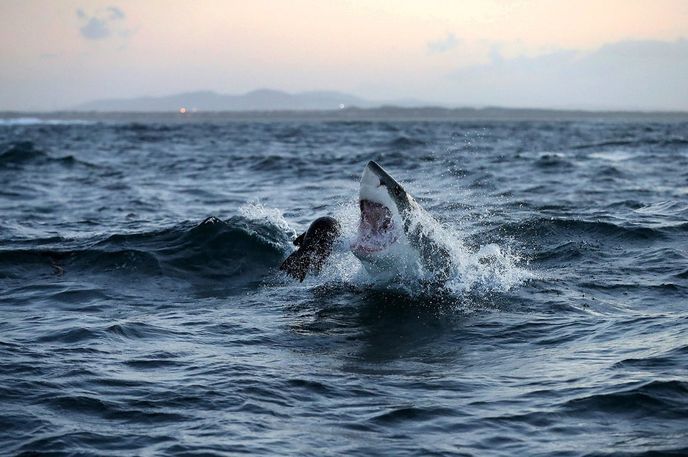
[0,0,688,110]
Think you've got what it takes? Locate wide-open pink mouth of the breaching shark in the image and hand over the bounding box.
[351,200,399,254]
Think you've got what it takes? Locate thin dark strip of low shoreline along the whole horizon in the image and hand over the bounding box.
[0,106,688,122]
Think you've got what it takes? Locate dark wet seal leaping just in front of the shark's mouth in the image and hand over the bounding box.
[280,216,341,281]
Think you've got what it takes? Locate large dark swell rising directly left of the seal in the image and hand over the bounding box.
[0,216,289,284]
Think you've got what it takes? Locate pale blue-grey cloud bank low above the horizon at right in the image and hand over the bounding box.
[450,39,688,110]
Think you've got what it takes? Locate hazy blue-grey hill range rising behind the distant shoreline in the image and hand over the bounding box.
[69,89,420,112]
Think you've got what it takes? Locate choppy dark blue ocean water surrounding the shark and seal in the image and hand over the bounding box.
[0,116,688,456]
